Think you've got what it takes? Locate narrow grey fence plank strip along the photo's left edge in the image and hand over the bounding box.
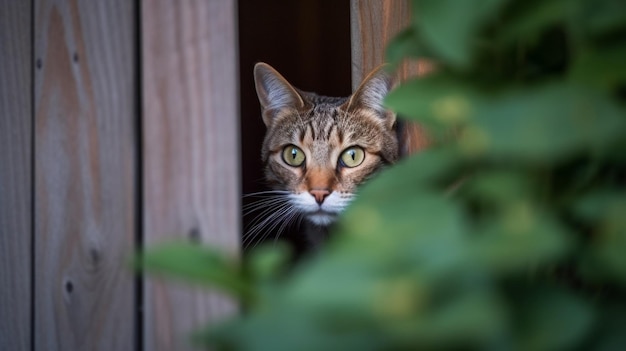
[0,0,32,350]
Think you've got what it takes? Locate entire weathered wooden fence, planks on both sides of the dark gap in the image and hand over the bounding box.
[0,0,415,351]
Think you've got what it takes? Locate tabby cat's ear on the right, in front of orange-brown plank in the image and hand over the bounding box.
[345,65,396,129]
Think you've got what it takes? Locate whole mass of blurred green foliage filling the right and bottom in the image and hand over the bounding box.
[140,0,626,351]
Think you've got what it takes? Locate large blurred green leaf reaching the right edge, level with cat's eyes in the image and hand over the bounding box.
[466,83,626,161]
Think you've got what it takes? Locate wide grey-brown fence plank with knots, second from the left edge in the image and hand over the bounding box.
[34,0,137,351]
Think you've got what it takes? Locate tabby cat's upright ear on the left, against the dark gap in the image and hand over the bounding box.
[254,62,304,127]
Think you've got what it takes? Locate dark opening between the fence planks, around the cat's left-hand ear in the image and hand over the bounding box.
[238,0,351,254]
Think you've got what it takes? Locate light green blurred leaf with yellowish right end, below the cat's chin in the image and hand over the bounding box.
[281,254,423,326]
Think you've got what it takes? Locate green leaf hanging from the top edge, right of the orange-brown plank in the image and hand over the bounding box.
[413,0,508,68]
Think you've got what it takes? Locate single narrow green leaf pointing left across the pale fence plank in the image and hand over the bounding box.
[136,242,251,298]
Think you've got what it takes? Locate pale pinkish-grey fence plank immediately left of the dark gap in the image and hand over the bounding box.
[142,0,240,350]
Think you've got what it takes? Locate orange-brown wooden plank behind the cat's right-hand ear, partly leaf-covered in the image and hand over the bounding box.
[350,0,433,154]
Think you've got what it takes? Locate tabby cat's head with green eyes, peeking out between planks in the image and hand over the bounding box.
[254,63,398,226]
